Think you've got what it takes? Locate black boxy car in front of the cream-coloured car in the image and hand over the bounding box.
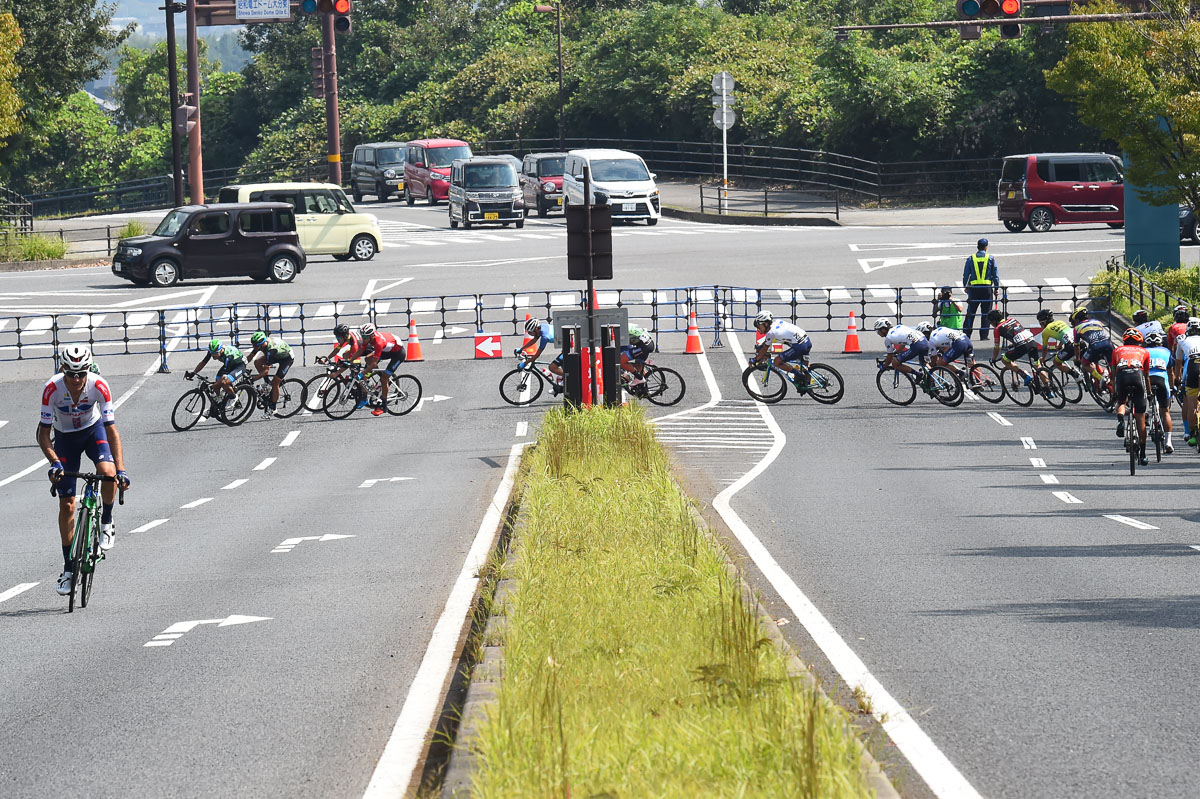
[113,203,305,287]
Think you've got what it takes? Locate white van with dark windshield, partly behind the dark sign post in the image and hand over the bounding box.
[563,150,660,224]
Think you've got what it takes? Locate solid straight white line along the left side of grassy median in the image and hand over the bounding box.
[362,441,529,799]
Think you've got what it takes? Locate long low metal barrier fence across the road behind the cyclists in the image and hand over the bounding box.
[0,283,1108,372]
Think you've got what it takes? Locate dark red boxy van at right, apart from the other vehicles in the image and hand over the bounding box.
[996,152,1124,233]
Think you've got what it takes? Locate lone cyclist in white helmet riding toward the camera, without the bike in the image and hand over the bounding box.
[37,344,130,596]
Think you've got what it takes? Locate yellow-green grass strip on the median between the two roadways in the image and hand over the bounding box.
[460,408,870,799]
